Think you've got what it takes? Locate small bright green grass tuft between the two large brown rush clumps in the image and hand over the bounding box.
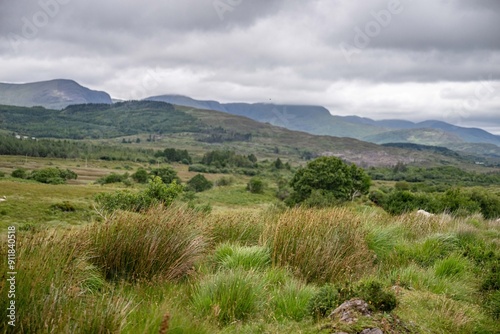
[213,243,271,270]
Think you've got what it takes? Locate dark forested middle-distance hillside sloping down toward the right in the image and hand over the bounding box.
[0,101,472,166]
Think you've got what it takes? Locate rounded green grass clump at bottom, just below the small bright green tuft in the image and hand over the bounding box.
[192,269,264,326]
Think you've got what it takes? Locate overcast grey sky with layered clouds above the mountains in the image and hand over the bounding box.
[0,0,500,133]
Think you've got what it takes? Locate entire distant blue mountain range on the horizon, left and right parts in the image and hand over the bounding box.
[0,80,500,150]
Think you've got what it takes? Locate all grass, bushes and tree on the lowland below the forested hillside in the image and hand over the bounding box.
[0,149,500,334]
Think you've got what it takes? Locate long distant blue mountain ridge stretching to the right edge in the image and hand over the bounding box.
[146,95,500,147]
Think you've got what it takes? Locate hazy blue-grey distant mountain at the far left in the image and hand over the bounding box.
[0,79,112,109]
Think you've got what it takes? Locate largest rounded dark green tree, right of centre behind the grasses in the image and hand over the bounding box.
[287,157,371,205]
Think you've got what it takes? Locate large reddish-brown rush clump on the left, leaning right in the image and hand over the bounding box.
[83,206,206,280]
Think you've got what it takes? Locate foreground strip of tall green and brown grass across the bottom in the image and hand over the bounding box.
[0,205,500,333]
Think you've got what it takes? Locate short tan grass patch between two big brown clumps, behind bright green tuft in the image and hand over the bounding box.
[203,210,264,246]
